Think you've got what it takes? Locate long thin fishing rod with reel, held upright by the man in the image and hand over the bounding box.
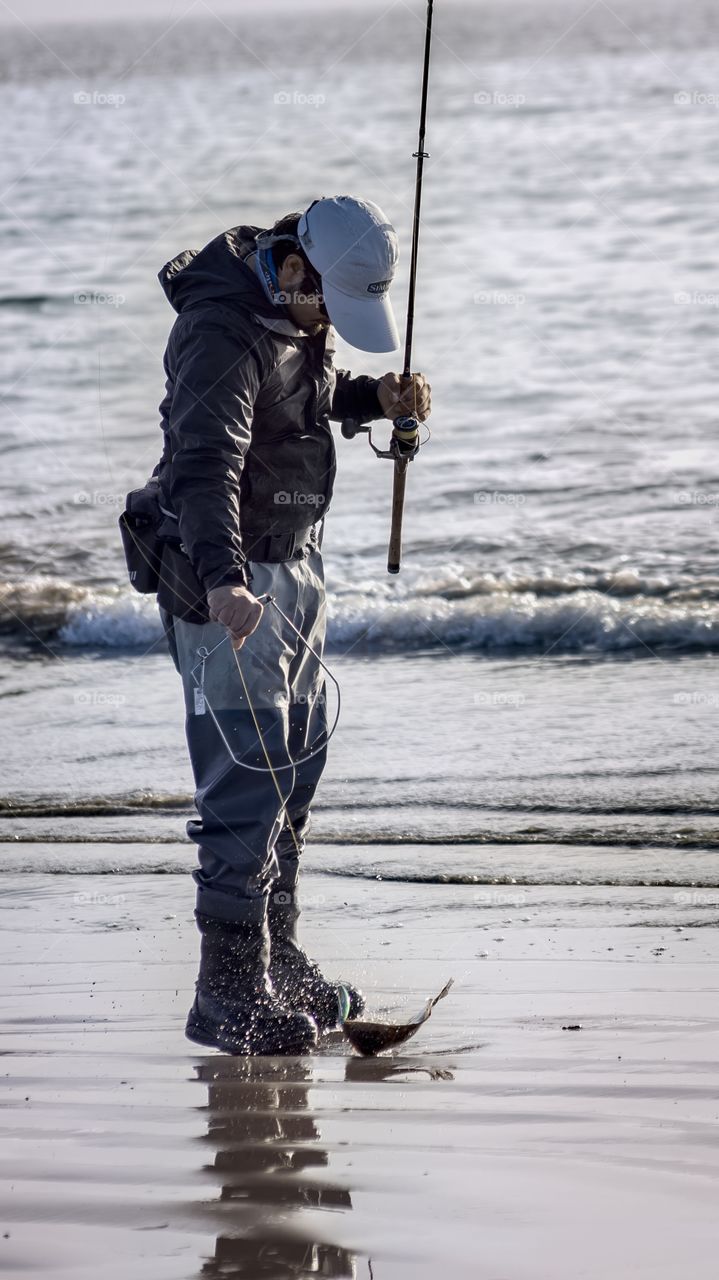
[342,0,434,573]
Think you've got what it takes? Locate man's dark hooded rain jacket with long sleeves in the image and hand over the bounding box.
[156,227,381,591]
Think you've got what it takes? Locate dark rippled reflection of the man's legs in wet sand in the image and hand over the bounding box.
[196,1057,357,1280]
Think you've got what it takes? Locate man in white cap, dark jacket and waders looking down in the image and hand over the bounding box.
[155,196,430,1053]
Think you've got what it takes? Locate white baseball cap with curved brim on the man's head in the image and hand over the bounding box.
[297,196,399,351]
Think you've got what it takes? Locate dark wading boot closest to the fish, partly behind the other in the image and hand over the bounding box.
[267,890,365,1032]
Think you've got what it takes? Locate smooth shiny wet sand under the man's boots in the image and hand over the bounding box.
[0,851,719,1280]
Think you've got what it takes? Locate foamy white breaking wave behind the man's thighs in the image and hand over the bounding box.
[0,567,719,657]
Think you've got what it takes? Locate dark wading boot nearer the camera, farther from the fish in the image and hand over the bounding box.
[186,911,317,1055]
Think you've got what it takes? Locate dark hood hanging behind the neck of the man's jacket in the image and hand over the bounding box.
[157,227,285,320]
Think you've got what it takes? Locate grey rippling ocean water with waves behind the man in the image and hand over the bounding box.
[0,0,719,886]
